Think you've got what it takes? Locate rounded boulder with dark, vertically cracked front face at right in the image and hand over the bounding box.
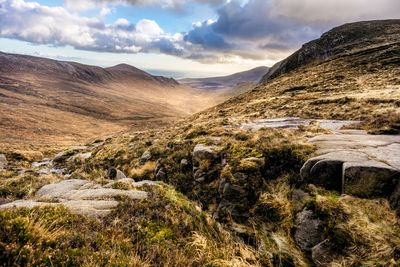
[300,151,400,198]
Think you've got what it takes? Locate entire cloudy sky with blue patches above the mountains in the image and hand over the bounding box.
[0,0,400,77]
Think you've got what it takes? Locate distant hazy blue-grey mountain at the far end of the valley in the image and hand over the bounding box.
[179,67,269,90]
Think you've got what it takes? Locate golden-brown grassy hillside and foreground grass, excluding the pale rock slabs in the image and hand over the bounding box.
[0,21,400,266]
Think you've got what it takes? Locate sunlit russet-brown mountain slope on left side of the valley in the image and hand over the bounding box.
[0,52,216,146]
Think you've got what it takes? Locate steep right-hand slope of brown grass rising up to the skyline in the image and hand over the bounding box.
[209,20,400,126]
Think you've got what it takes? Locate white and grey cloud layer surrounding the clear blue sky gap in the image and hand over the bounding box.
[0,0,400,63]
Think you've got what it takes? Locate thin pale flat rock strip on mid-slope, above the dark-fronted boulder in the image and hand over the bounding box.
[239,117,357,131]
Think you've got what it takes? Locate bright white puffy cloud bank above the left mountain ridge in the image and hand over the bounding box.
[0,0,174,53]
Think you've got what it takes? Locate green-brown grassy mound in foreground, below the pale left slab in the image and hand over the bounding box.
[0,187,265,266]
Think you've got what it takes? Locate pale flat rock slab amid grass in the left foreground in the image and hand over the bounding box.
[0,179,148,217]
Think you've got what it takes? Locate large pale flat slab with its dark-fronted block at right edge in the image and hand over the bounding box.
[300,132,400,205]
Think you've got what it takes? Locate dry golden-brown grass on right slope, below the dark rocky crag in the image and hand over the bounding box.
[190,43,400,133]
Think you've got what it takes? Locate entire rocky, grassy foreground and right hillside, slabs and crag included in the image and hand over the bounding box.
[0,20,400,266]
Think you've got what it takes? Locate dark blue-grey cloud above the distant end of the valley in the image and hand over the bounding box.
[184,0,320,59]
